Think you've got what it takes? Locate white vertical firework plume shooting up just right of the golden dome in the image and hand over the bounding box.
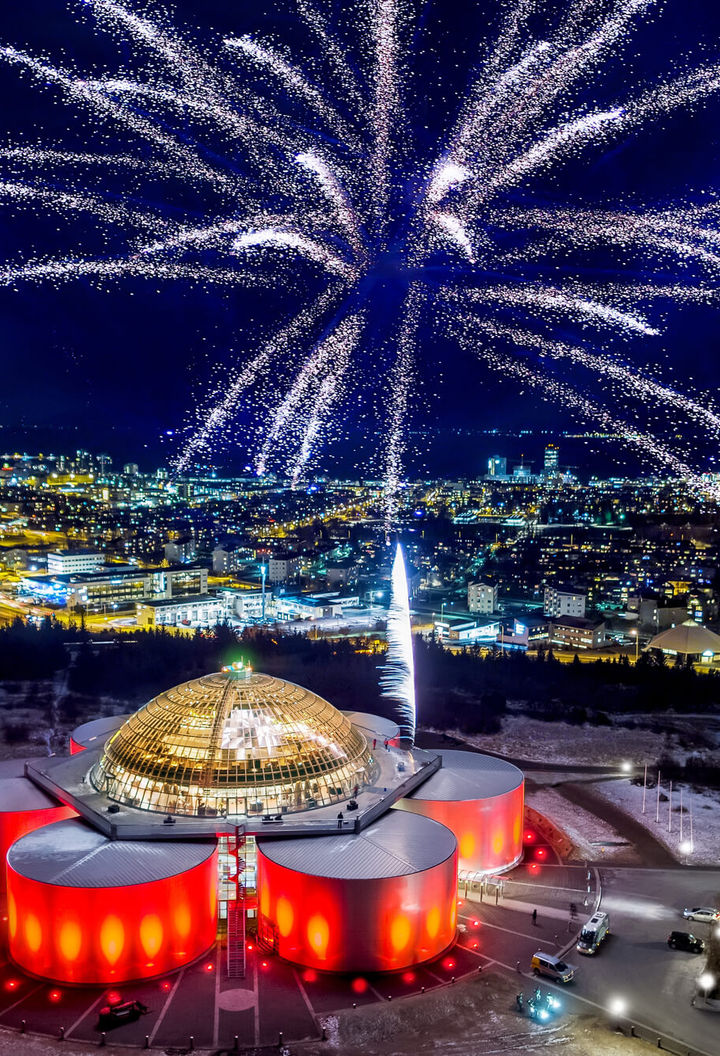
[380,543,416,744]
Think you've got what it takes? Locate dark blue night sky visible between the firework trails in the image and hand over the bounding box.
[0,0,720,469]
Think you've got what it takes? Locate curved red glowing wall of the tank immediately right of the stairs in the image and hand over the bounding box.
[258,847,457,972]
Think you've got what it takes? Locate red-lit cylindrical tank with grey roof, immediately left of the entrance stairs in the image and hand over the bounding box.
[7,821,217,984]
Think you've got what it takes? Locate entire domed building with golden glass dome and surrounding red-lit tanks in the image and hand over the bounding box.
[0,664,524,984]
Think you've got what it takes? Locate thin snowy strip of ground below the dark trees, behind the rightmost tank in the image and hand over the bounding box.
[447,715,675,767]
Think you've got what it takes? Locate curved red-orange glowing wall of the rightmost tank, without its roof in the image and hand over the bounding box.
[395,782,525,872]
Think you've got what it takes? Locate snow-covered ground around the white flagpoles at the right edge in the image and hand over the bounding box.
[582,778,720,865]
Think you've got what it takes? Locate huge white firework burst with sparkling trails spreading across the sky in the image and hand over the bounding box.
[0,0,720,504]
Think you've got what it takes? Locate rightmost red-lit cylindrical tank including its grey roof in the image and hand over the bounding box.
[395,751,525,876]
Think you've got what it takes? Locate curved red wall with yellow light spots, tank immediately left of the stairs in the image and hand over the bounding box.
[7,850,217,983]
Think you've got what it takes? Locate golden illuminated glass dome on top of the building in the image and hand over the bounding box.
[90,664,375,816]
